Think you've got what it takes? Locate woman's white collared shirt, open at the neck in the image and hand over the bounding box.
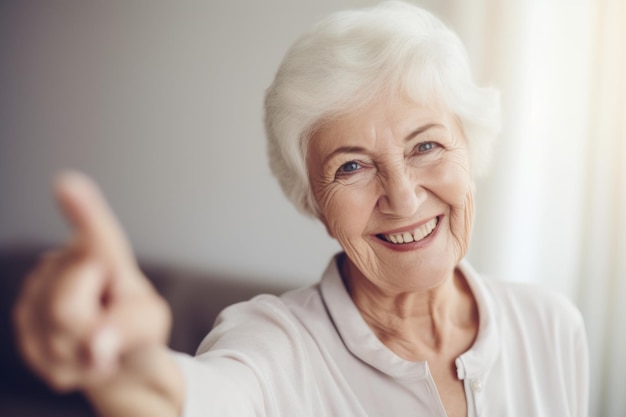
[175,258,589,417]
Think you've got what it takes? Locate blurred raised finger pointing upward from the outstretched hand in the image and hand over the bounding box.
[54,171,133,265]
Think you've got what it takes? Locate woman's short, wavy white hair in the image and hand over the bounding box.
[265,1,500,217]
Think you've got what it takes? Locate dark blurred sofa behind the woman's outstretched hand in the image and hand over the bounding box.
[0,245,288,417]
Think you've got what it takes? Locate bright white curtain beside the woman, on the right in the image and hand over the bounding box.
[431,0,626,417]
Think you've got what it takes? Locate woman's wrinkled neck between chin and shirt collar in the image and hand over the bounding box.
[342,258,478,360]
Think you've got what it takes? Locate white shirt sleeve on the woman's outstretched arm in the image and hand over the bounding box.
[166,296,318,417]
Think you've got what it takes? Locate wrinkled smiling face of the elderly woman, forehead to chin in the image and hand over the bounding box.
[307,95,473,291]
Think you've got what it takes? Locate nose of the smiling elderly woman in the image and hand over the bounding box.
[378,167,426,217]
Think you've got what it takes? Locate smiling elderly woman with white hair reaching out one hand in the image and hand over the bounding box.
[15,3,588,417]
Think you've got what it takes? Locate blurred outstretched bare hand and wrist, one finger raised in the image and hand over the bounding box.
[14,173,184,416]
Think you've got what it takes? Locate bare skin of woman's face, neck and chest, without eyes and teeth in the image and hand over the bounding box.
[307,97,478,412]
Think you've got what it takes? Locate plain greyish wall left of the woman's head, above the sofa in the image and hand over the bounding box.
[0,0,478,285]
